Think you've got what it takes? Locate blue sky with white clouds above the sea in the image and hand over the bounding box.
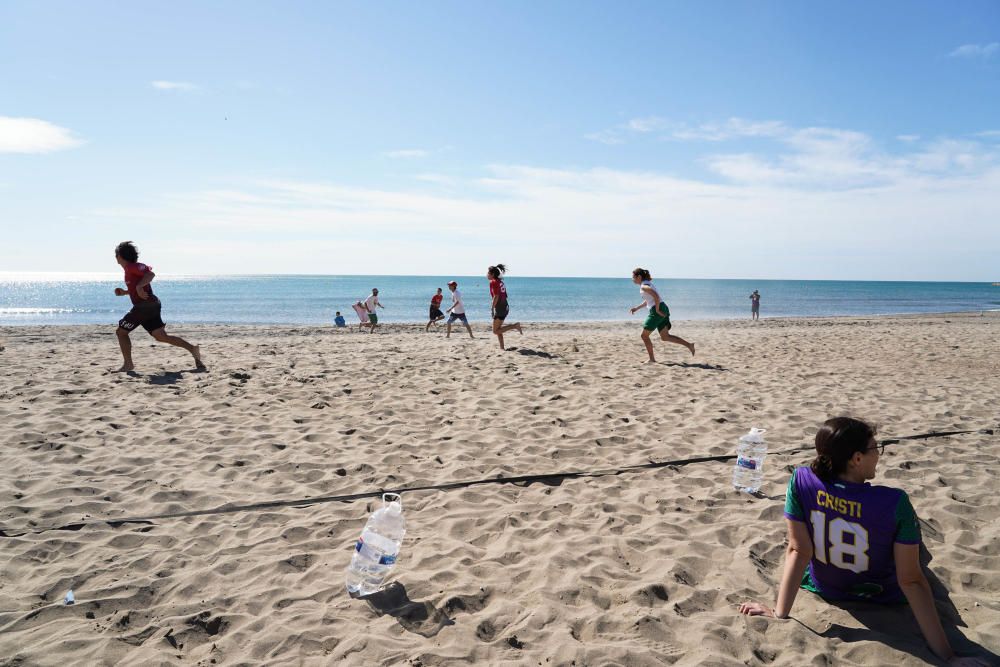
[0,0,1000,281]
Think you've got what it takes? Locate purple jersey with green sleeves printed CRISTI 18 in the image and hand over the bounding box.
[785,468,920,602]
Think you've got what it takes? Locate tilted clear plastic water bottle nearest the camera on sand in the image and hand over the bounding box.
[347,493,406,596]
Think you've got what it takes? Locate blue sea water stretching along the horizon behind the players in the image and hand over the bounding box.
[0,275,1000,325]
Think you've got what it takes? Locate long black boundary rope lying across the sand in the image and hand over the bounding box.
[0,428,994,537]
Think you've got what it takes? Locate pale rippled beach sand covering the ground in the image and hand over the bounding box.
[0,313,1000,665]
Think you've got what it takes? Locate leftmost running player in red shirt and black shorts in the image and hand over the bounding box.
[115,241,206,372]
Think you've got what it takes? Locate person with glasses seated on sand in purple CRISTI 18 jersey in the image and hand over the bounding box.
[740,417,986,665]
